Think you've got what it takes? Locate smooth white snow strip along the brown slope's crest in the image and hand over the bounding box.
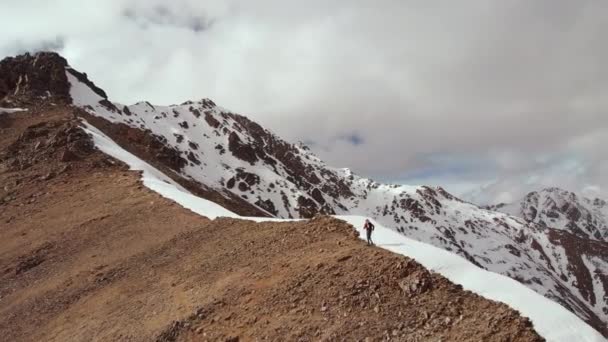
[79,123,604,342]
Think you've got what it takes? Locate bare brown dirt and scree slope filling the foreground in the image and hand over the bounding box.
[0,108,542,341]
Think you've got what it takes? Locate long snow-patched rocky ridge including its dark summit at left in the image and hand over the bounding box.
[0,54,608,336]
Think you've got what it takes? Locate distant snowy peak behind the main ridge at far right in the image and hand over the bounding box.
[488,188,608,241]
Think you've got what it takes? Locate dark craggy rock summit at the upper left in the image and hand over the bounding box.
[0,52,71,106]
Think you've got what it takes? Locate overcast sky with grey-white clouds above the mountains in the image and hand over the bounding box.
[0,0,608,202]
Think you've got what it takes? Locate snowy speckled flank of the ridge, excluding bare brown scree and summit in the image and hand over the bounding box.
[66,67,608,336]
